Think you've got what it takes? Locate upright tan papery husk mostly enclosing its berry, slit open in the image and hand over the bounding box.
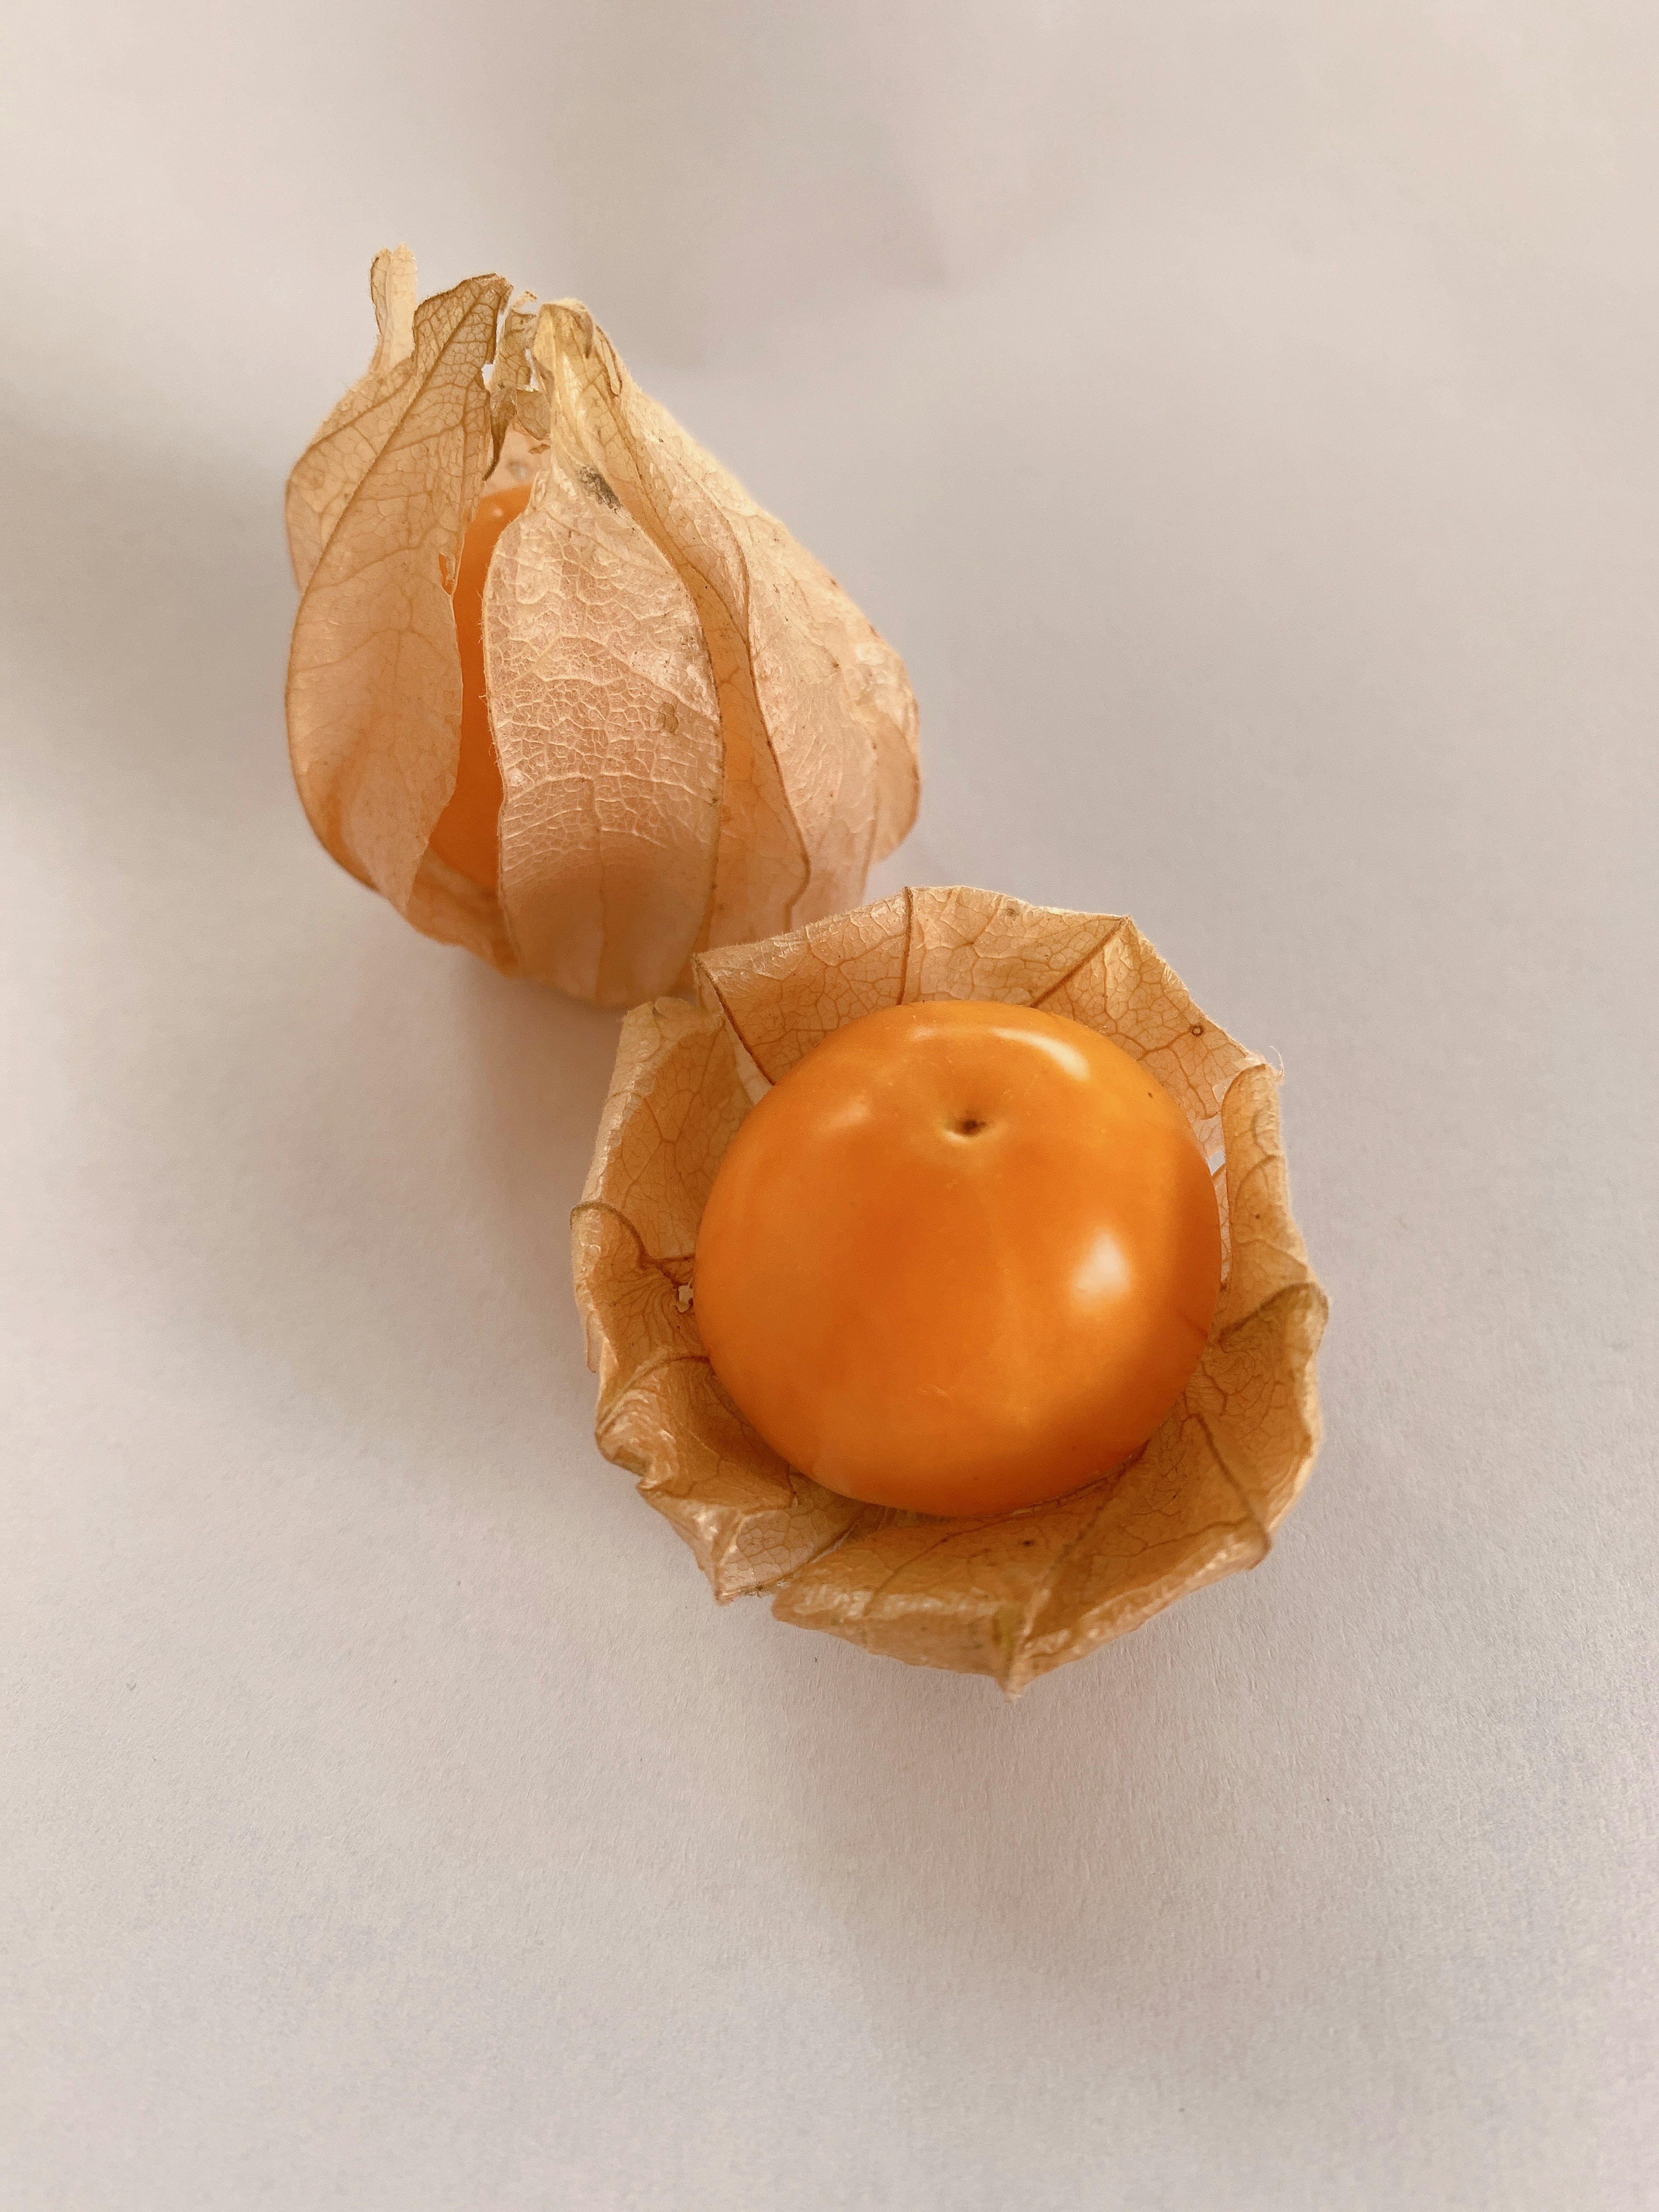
[288,245,918,1004]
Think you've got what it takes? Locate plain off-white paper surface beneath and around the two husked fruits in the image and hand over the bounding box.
[0,0,1659,2212]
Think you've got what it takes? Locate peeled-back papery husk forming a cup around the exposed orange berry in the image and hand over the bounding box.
[573,887,1325,1697]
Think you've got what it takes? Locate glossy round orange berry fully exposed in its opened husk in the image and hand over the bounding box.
[695,1000,1221,1515]
